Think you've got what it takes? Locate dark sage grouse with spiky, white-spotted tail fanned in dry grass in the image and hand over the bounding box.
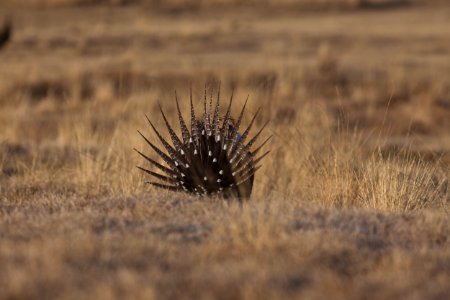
[134,88,271,199]
